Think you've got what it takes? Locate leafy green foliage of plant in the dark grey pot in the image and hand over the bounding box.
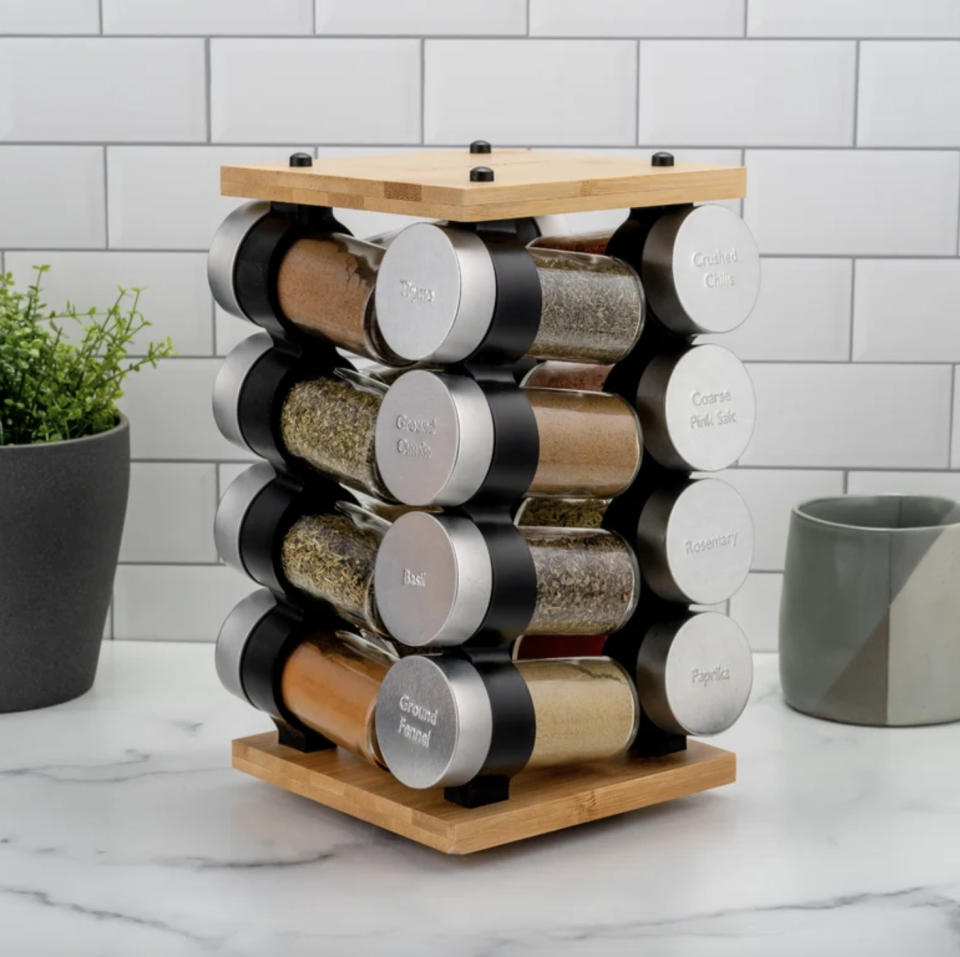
[0,266,174,446]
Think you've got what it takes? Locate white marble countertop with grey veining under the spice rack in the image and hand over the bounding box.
[0,642,960,957]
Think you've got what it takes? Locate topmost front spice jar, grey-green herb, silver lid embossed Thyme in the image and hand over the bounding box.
[376,223,644,363]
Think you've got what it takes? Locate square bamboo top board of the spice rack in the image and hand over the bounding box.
[220,149,747,222]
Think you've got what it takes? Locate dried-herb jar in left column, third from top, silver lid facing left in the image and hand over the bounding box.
[214,462,389,634]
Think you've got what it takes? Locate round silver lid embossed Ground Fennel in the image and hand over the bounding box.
[376,655,493,788]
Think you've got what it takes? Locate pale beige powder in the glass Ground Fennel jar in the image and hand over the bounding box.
[517,658,640,768]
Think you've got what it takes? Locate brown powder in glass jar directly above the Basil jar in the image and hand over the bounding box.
[524,389,642,498]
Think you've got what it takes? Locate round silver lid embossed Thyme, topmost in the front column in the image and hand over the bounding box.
[376,223,497,362]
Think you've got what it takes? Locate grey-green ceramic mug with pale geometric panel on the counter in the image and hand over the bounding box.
[780,495,960,725]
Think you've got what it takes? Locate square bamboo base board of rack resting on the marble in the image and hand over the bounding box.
[233,732,736,854]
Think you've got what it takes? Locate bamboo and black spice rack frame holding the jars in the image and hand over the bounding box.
[211,143,745,853]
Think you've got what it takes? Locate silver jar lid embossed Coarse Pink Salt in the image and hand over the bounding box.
[637,345,757,472]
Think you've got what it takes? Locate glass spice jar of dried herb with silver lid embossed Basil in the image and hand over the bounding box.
[374,512,640,646]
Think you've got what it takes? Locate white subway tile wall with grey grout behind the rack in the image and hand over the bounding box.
[0,0,960,649]
